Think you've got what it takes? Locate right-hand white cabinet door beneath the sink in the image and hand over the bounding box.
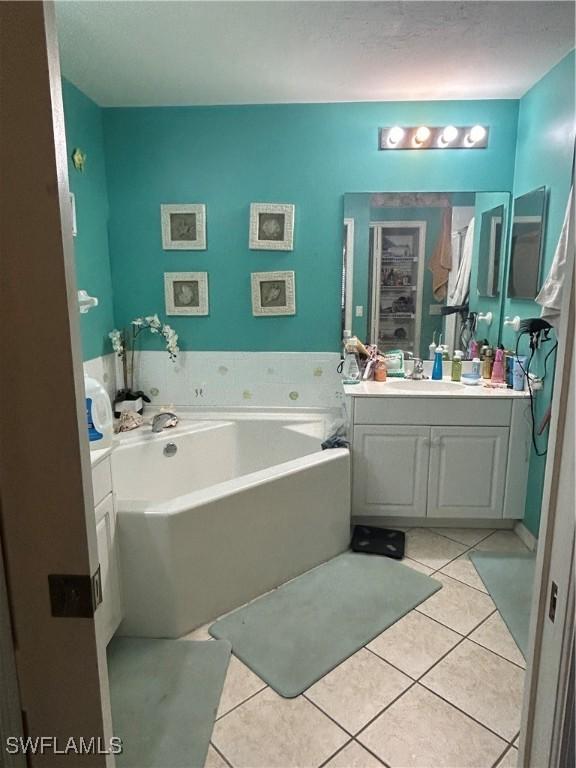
[428,427,509,518]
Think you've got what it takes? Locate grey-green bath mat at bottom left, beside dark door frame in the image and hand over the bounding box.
[108,637,230,768]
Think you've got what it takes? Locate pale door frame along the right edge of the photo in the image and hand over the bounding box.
[519,184,576,768]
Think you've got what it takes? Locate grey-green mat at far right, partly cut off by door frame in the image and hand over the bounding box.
[470,552,536,658]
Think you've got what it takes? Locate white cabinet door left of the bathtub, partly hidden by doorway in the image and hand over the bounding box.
[96,494,122,644]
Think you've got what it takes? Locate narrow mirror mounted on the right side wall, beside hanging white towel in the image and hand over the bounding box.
[508,187,546,299]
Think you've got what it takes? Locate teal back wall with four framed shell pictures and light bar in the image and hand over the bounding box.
[104,100,518,351]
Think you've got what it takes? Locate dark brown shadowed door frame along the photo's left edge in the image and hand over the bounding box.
[0,0,114,768]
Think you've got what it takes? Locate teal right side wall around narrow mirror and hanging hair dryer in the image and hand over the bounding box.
[502,51,575,535]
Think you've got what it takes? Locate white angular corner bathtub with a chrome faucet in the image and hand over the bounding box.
[112,414,350,637]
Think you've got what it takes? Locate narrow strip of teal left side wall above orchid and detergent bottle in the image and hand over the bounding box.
[62,80,114,360]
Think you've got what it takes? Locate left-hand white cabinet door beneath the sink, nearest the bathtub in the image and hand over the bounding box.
[352,425,430,517]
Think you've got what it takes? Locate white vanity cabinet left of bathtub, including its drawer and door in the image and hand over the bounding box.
[92,456,122,644]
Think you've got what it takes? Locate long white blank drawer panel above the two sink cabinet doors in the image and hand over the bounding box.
[354,397,512,427]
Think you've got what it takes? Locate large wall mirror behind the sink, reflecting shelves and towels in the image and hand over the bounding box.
[342,192,510,358]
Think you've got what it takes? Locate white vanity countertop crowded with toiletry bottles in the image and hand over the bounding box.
[343,377,529,399]
